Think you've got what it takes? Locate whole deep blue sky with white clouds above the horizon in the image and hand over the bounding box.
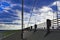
[0,0,60,29]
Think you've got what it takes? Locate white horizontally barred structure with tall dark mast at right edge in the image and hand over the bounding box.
[53,2,60,29]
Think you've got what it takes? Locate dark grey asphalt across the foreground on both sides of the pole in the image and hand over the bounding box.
[2,30,60,40]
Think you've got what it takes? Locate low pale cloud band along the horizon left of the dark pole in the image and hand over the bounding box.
[0,24,21,30]
